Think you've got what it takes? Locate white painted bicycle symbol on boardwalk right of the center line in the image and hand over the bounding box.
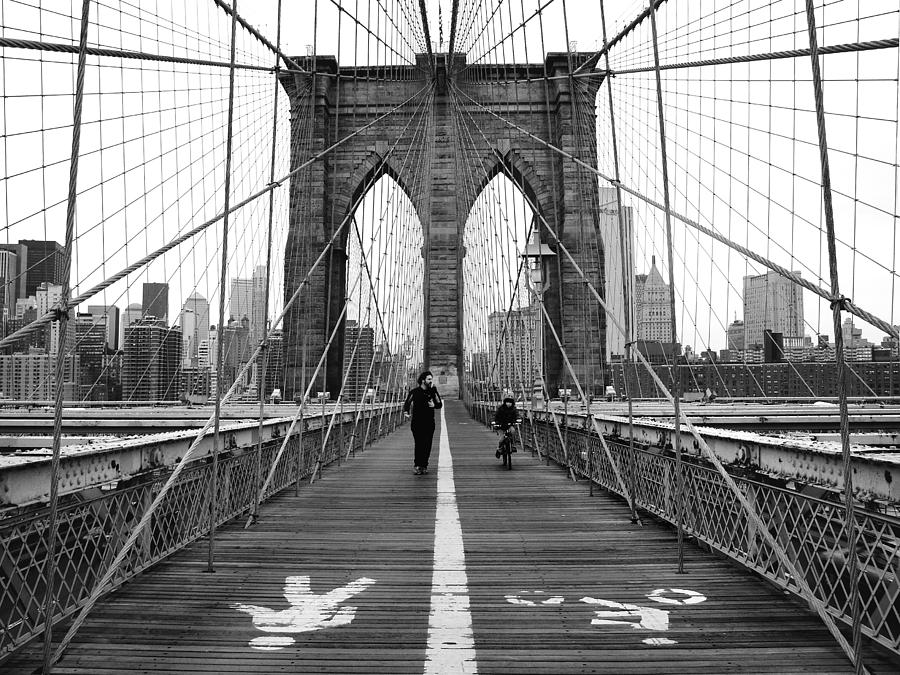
[505,588,706,647]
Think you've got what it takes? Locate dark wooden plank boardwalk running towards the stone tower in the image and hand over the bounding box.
[0,402,900,675]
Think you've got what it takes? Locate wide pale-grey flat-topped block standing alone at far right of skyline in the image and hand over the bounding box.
[744,272,804,350]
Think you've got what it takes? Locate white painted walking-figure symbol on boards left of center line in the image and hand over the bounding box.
[232,575,375,650]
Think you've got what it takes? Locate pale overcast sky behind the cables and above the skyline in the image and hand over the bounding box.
[0,0,900,360]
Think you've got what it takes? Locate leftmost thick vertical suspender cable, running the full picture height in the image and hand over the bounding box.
[43,0,91,673]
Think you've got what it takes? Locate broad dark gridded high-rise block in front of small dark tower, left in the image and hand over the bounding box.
[122,318,181,401]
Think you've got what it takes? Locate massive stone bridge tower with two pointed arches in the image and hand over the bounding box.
[281,53,606,397]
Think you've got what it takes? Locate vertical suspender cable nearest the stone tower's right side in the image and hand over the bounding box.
[600,0,637,523]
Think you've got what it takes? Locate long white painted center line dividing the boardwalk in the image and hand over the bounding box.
[425,408,478,675]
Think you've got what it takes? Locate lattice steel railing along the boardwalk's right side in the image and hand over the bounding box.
[472,404,900,655]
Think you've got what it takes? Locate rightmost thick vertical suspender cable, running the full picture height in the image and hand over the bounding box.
[806,0,864,675]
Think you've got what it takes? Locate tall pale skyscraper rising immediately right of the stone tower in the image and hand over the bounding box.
[600,188,635,357]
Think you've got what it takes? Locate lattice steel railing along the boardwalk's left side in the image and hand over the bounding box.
[0,407,402,661]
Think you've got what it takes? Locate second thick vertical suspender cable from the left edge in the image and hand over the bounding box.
[206,0,237,572]
